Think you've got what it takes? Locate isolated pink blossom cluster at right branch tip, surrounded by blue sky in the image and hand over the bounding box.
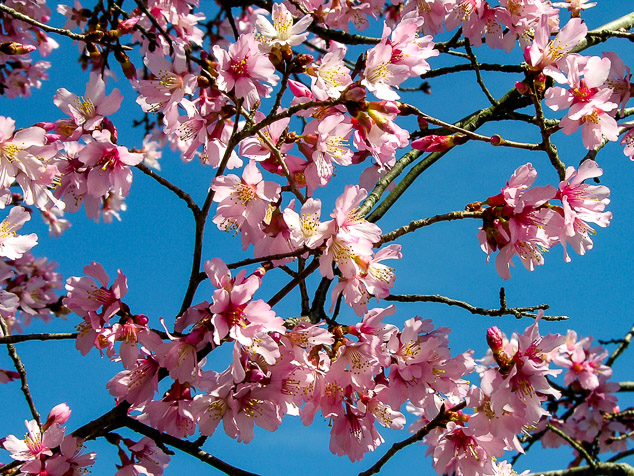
[470,160,612,279]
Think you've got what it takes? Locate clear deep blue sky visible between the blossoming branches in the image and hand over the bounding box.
[0,2,634,475]
